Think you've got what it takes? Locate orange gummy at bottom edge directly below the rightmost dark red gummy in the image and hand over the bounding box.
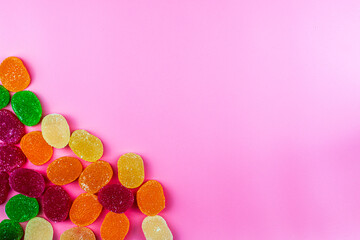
[100,212,130,240]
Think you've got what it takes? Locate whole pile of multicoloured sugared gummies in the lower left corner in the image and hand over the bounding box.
[0,57,173,240]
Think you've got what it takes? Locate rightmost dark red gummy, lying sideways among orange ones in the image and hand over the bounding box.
[98,184,134,213]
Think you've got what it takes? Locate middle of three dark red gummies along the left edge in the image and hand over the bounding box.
[0,145,26,172]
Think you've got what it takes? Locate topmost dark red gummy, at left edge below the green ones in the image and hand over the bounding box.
[0,109,25,144]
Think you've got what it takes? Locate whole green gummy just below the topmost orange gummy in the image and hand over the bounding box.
[11,91,42,126]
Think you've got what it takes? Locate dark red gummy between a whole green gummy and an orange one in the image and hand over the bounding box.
[43,186,71,222]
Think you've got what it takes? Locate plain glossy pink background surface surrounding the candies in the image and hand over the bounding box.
[0,0,360,240]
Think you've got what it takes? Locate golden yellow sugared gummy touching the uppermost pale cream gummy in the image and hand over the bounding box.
[69,130,104,162]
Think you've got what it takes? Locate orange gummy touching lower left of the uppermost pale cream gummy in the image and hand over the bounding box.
[20,131,53,165]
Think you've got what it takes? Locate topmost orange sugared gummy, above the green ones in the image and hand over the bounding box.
[0,57,30,92]
